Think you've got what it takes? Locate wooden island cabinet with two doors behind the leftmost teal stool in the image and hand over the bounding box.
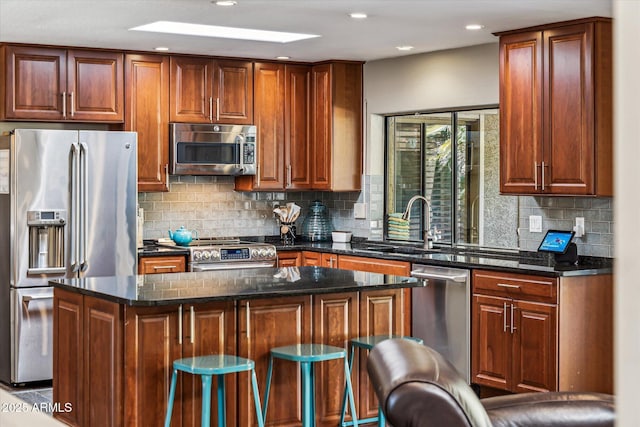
[124,302,236,426]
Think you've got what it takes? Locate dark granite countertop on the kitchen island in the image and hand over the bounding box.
[50,267,424,306]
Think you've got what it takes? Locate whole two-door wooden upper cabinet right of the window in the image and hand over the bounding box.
[498,18,613,196]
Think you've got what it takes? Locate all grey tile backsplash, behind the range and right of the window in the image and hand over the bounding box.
[138,175,614,258]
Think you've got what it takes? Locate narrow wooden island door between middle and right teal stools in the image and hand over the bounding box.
[313,292,358,426]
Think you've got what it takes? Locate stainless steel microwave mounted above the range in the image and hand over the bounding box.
[170,123,257,175]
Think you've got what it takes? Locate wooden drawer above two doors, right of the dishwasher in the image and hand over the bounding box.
[472,270,558,304]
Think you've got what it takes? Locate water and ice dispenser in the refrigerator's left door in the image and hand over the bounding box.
[27,209,67,274]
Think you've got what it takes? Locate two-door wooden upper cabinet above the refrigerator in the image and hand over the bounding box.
[2,45,124,122]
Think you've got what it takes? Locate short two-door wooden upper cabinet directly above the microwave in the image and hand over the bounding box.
[170,56,253,124]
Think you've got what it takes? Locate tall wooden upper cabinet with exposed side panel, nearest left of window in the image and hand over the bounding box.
[311,62,362,191]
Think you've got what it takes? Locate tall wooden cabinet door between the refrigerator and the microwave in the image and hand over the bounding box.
[124,55,169,191]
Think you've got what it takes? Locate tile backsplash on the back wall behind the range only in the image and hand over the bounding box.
[138,176,372,239]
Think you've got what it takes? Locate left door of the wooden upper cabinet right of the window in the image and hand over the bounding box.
[500,31,544,194]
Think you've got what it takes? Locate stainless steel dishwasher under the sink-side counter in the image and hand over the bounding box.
[411,264,471,384]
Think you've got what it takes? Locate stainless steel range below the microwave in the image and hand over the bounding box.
[159,238,277,271]
